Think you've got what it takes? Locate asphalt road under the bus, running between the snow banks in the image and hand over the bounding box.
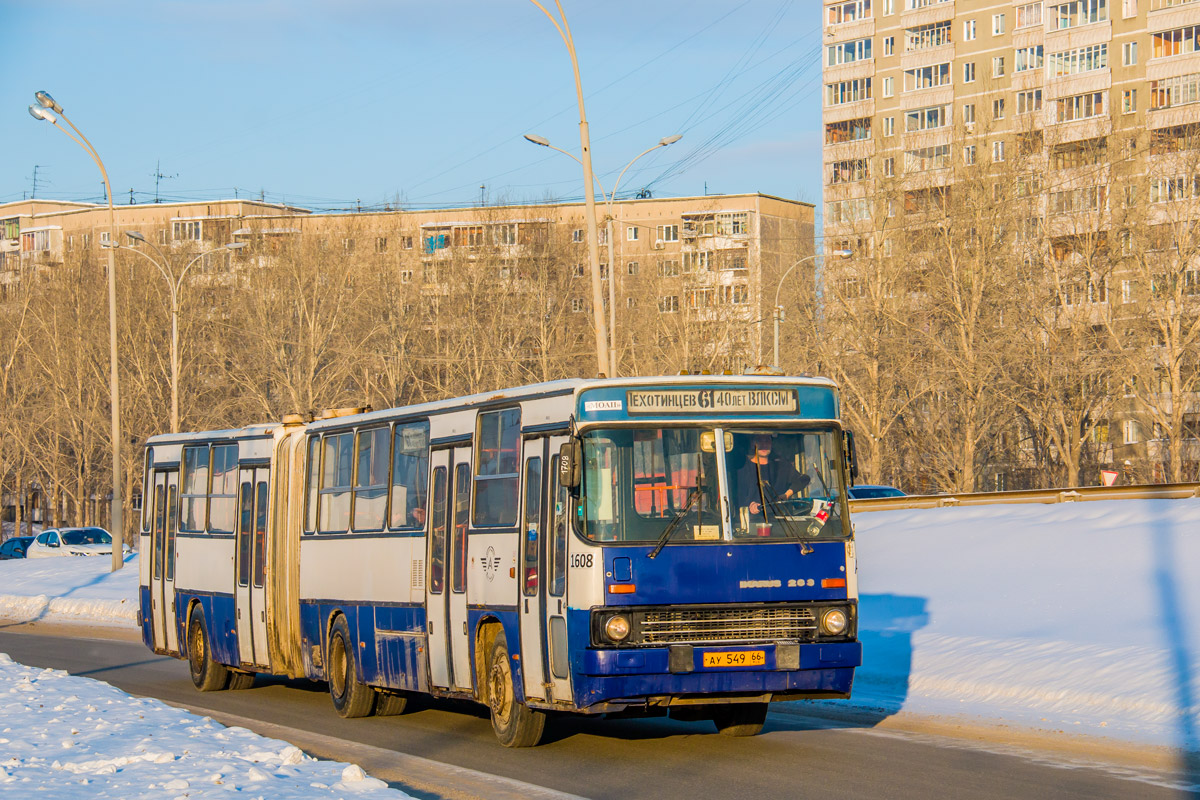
[0,625,1200,800]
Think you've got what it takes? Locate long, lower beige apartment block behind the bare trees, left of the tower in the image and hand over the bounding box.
[0,193,814,366]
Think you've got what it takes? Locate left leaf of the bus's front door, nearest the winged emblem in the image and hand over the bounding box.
[517,437,549,700]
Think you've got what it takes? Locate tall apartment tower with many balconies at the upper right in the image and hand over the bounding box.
[822,0,1200,480]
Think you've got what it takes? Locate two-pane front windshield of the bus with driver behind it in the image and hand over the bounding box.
[578,428,848,543]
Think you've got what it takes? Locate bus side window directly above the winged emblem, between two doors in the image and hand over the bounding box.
[474,408,521,527]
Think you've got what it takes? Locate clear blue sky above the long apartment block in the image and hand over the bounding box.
[0,0,821,209]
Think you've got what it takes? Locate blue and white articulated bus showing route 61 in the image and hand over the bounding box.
[139,375,862,746]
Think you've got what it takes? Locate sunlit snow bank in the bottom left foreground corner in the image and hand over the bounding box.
[0,652,409,800]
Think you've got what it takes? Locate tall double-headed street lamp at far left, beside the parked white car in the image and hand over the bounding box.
[29,91,125,572]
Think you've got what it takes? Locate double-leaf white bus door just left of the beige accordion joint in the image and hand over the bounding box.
[234,467,270,667]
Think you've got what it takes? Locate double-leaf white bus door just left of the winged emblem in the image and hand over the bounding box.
[425,447,472,688]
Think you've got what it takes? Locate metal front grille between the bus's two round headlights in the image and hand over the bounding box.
[637,606,817,645]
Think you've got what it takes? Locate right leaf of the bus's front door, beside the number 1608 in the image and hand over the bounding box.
[541,437,574,700]
